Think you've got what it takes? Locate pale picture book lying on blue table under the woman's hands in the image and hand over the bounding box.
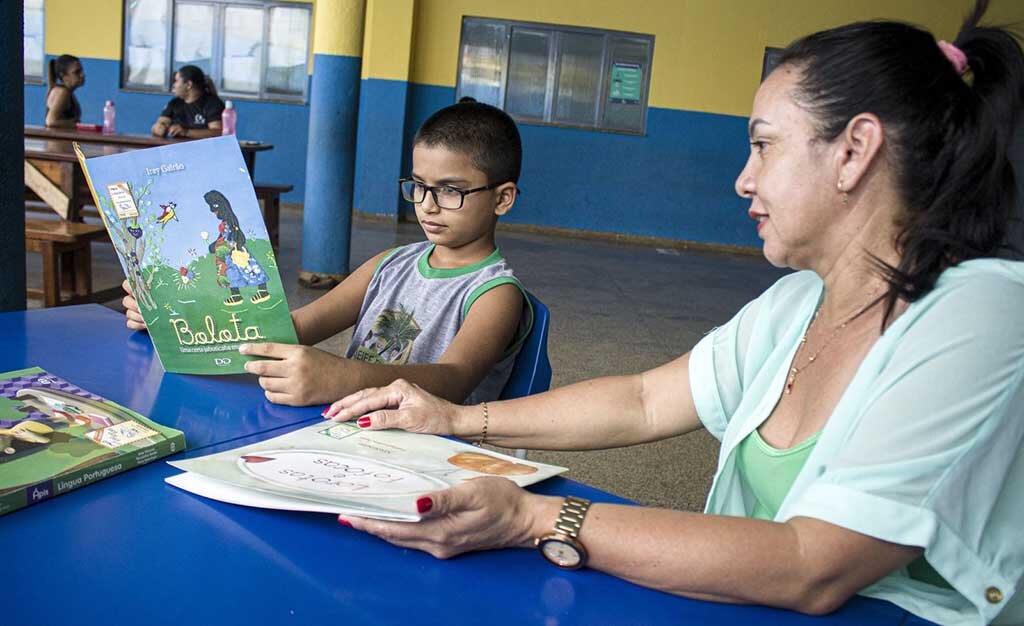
[165,421,566,521]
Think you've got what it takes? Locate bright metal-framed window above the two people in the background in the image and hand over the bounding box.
[121,0,312,102]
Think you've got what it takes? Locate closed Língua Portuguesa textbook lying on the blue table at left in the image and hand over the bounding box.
[0,368,185,515]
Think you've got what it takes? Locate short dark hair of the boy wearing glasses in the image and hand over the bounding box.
[413,98,522,184]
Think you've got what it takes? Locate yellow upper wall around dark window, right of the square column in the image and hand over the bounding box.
[411,0,1024,116]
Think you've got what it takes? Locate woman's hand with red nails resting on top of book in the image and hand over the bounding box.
[324,379,464,434]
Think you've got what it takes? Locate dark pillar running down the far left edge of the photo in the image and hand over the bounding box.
[0,0,25,311]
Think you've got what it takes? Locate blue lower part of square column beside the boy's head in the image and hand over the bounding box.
[355,79,410,218]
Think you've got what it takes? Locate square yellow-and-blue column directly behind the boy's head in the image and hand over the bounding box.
[354,0,416,221]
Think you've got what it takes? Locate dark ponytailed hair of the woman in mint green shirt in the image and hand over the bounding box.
[778,0,1024,325]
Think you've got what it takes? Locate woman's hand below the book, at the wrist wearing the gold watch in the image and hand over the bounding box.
[338,476,561,558]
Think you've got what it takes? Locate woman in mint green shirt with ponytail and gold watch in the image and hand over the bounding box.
[325,0,1024,624]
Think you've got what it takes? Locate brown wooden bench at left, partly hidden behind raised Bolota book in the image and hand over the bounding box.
[25,218,121,306]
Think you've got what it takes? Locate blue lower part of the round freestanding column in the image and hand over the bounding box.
[302,54,362,274]
